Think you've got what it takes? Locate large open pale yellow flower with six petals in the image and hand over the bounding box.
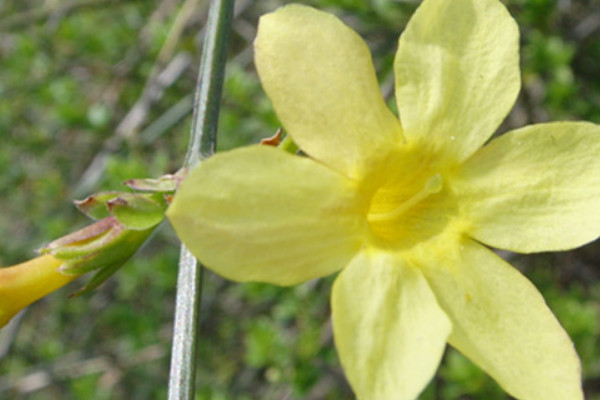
[168,0,600,400]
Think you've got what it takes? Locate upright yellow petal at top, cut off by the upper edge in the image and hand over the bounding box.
[394,0,520,160]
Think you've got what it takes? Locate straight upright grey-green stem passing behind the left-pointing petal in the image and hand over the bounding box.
[168,0,234,400]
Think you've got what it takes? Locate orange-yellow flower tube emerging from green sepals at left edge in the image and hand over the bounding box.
[0,255,78,328]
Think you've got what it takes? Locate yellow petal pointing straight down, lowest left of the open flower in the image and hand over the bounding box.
[332,252,451,400]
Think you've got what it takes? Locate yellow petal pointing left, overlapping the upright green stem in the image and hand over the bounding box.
[167,146,366,285]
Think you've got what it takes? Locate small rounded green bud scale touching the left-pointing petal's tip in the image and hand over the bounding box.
[106,193,168,230]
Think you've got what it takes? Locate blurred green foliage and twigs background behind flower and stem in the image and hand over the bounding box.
[0,0,600,400]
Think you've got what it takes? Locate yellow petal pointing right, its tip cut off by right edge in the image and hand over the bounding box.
[450,122,600,252]
